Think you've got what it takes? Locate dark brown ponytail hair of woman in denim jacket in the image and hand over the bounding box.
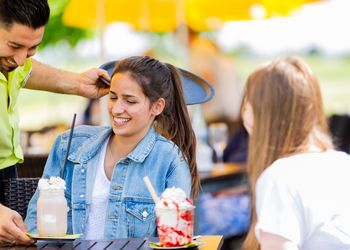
[114,56,200,199]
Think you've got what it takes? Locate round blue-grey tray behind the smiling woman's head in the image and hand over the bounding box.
[100,60,215,105]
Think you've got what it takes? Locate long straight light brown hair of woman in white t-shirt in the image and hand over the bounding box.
[242,57,333,250]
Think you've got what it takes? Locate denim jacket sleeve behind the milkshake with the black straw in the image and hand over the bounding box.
[24,136,65,233]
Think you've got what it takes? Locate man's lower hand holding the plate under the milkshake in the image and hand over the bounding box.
[0,204,35,245]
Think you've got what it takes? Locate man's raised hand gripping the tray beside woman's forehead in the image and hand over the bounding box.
[77,68,110,98]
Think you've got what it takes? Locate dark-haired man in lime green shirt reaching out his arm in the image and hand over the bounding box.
[0,0,109,244]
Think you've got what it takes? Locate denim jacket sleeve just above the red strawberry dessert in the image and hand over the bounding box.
[166,155,192,197]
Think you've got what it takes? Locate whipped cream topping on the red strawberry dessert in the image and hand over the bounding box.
[156,187,194,209]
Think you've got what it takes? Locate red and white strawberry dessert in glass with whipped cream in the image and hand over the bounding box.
[156,187,195,247]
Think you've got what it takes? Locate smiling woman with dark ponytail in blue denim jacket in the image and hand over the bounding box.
[25,57,199,239]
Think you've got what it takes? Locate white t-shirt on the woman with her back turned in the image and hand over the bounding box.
[255,150,350,250]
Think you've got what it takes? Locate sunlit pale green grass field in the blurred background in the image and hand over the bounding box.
[18,55,350,130]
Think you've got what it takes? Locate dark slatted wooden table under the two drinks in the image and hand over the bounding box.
[0,235,224,250]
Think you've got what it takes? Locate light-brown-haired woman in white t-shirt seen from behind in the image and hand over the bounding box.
[242,57,350,250]
